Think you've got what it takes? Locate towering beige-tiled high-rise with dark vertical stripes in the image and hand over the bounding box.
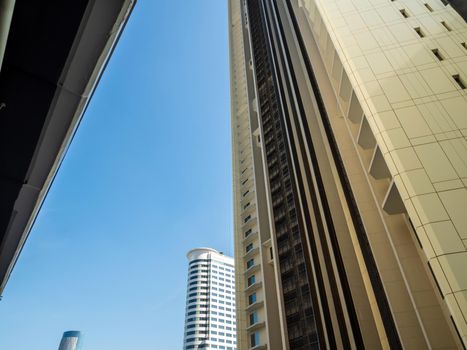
[229,0,467,350]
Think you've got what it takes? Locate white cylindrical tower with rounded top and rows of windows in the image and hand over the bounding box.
[183,248,237,350]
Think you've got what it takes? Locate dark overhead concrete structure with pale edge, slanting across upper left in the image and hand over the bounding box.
[0,0,135,294]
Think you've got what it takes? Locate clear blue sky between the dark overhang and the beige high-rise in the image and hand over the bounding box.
[0,0,233,350]
